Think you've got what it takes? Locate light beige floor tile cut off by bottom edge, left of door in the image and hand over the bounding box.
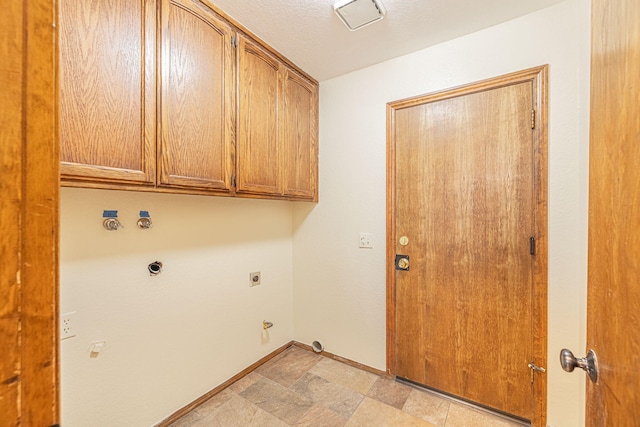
[345,397,435,427]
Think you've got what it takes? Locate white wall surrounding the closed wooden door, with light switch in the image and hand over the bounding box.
[293,0,589,427]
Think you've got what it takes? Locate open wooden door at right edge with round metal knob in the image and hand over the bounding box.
[574,0,640,427]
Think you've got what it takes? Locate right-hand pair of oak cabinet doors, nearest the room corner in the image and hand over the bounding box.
[236,36,318,200]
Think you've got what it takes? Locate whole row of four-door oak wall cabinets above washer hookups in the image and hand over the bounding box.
[59,0,318,201]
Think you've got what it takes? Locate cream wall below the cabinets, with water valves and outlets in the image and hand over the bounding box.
[60,188,293,427]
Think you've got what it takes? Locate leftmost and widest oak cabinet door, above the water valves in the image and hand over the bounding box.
[58,0,156,185]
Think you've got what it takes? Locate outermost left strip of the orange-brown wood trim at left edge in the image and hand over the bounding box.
[0,0,24,426]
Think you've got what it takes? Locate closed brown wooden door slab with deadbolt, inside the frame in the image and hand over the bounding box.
[390,68,546,420]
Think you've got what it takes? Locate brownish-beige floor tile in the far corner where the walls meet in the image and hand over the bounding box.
[256,347,322,387]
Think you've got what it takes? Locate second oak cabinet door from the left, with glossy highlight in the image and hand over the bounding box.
[159,0,234,191]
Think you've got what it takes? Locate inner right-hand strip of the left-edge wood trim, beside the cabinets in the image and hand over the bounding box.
[21,0,60,426]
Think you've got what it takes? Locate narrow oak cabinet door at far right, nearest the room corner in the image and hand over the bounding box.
[279,69,318,200]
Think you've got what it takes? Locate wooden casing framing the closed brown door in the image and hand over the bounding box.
[386,65,549,427]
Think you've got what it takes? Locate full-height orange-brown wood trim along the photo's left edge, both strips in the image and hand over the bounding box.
[0,0,60,426]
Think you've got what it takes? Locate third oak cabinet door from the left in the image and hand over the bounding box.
[236,36,282,195]
